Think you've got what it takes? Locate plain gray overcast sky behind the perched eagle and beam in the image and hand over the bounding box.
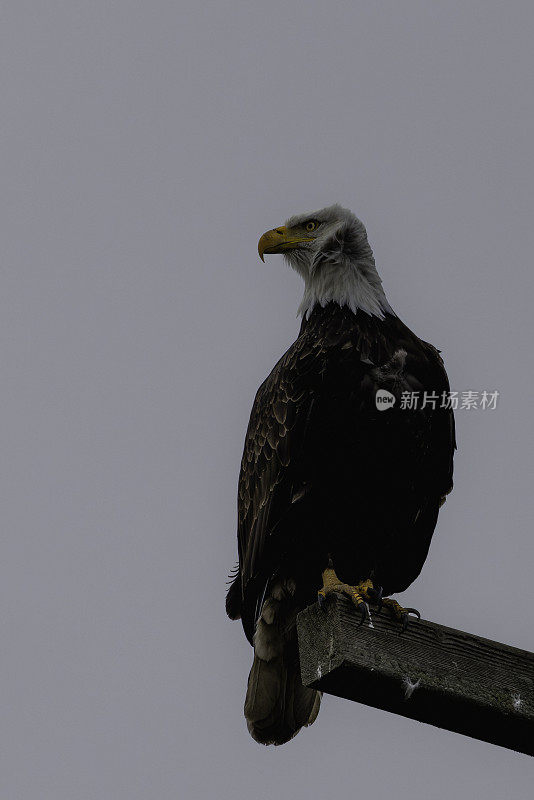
[0,0,534,800]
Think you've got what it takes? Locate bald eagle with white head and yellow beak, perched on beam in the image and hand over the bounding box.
[226,205,455,744]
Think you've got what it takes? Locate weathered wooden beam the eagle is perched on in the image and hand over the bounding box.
[297,596,534,755]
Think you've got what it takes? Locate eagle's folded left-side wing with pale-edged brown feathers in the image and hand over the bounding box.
[237,336,325,638]
